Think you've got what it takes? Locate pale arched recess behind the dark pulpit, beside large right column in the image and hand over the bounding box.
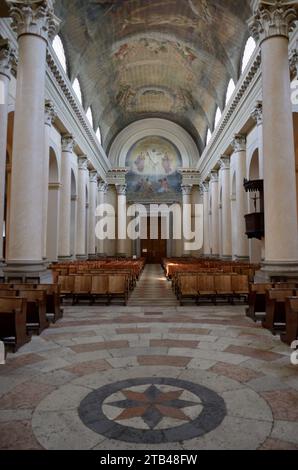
[248,149,264,263]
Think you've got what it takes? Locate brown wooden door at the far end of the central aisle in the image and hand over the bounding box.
[141,217,167,264]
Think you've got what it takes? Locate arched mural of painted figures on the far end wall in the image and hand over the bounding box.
[126,136,182,203]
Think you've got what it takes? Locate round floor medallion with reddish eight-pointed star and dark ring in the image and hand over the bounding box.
[79,378,226,444]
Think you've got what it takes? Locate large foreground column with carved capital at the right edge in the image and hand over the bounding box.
[250,1,298,277]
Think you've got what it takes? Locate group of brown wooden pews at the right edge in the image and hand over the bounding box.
[247,282,298,344]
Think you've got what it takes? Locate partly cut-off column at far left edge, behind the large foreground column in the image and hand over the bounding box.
[0,39,15,265]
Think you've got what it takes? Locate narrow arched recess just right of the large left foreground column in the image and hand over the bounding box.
[47,147,60,262]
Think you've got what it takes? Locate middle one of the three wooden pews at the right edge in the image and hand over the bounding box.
[263,289,295,334]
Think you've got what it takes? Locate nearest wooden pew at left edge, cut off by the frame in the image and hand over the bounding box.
[0,296,30,352]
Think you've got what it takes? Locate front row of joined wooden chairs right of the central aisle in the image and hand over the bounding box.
[176,273,249,305]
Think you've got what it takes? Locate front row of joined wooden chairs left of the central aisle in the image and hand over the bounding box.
[58,274,130,305]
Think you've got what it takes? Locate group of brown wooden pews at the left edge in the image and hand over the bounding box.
[0,284,63,350]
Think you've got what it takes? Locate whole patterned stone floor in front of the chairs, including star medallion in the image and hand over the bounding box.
[0,278,298,450]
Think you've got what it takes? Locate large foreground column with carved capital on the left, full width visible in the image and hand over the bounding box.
[6,0,57,274]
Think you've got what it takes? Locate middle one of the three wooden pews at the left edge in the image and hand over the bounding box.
[19,289,49,335]
